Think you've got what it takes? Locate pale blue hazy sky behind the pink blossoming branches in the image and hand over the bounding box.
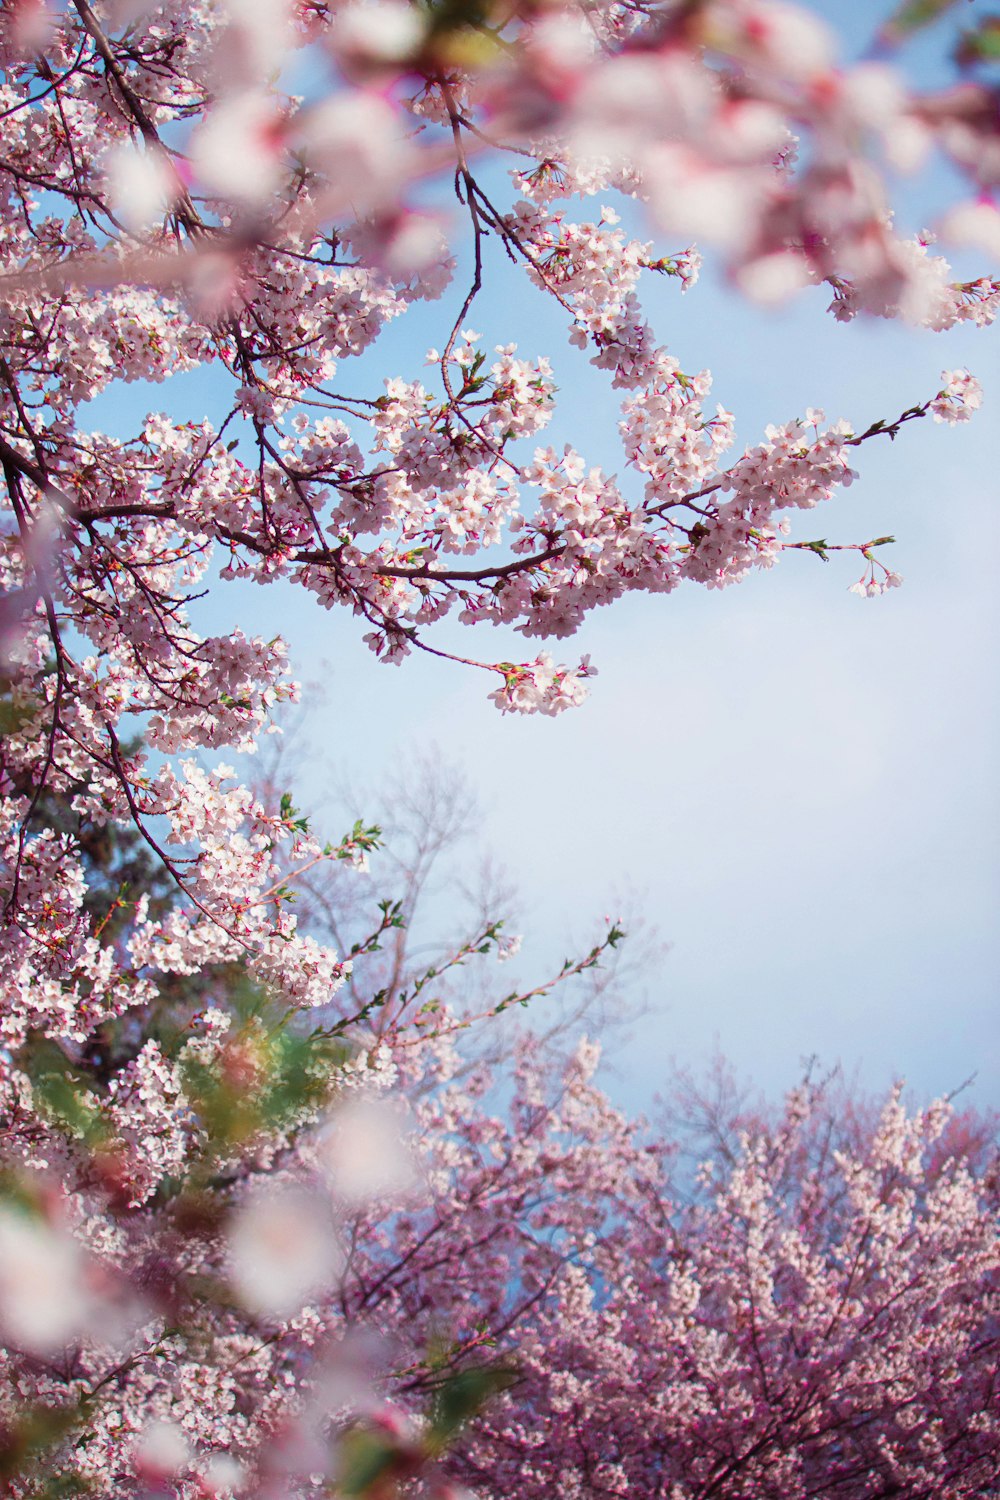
[88,6,1000,1104]
